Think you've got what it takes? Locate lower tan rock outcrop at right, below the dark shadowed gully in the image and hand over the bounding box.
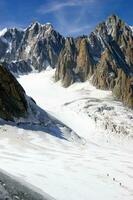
[92,49,133,108]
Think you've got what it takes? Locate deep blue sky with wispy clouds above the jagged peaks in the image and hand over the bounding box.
[0,0,133,36]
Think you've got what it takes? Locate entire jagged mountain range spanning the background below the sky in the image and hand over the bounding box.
[0,15,133,108]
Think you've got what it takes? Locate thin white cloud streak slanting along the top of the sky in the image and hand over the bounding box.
[37,0,95,15]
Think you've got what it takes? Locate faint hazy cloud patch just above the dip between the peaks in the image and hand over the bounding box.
[50,3,94,37]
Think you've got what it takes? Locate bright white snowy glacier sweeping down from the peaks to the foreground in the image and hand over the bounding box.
[0,70,133,200]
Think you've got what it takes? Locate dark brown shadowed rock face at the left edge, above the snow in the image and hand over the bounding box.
[0,65,28,120]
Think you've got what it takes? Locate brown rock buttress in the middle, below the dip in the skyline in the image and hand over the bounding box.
[55,37,95,87]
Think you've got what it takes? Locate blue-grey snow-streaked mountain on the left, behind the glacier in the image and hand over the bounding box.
[0,22,64,73]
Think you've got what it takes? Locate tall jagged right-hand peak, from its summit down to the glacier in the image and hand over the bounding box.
[93,16,133,108]
